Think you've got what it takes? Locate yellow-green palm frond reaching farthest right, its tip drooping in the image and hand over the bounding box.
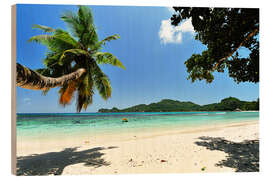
[94,52,126,70]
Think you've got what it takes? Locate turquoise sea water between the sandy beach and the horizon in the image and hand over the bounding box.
[17,112,259,137]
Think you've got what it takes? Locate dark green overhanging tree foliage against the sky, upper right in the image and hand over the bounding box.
[171,7,259,83]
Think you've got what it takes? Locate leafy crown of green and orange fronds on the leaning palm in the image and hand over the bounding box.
[24,6,125,112]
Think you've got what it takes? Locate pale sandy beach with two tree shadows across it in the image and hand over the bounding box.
[17,121,259,175]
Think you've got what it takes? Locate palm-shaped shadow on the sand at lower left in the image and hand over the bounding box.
[17,146,117,175]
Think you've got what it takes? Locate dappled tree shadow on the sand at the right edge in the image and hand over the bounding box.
[195,136,259,172]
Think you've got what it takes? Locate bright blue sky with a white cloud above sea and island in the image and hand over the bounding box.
[16,5,259,112]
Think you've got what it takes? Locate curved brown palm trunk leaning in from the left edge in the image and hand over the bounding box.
[16,63,86,90]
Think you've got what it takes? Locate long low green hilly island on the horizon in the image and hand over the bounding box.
[98,97,259,112]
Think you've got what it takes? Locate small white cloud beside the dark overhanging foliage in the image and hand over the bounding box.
[159,19,194,44]
